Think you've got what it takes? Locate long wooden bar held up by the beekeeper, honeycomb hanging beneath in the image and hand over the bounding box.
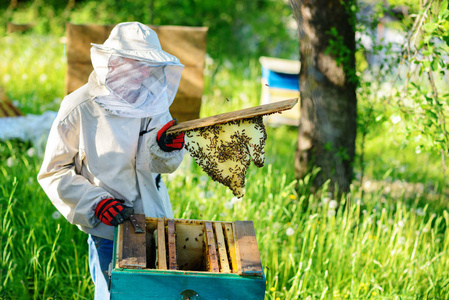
[167,98,298,134]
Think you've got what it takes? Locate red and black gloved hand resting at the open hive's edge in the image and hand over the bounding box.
[95,198,134,226]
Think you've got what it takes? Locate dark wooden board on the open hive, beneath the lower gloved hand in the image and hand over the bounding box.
[119,214,147,269]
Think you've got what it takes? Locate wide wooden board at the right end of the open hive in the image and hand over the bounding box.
[234,221,263,276]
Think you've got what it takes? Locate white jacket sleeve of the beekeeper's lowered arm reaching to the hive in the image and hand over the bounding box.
[37,112,112,228]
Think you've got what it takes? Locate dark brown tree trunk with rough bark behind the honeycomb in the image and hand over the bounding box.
[290,0,357,192]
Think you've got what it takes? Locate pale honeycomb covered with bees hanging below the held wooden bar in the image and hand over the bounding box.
[186,116,267,198]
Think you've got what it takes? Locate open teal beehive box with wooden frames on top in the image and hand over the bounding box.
[110,215,266,300]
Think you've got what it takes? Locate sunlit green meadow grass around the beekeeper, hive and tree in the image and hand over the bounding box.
[0,35,449,300]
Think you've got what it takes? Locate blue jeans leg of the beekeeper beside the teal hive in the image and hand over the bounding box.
[87,234,113,300]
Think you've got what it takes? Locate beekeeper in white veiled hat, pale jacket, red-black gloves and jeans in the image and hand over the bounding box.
[38,22,185,299]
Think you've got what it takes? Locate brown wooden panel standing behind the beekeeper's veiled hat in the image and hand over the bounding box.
[66,23,208,122]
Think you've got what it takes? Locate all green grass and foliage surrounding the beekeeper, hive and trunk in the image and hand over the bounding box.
[0,0,449,300]
